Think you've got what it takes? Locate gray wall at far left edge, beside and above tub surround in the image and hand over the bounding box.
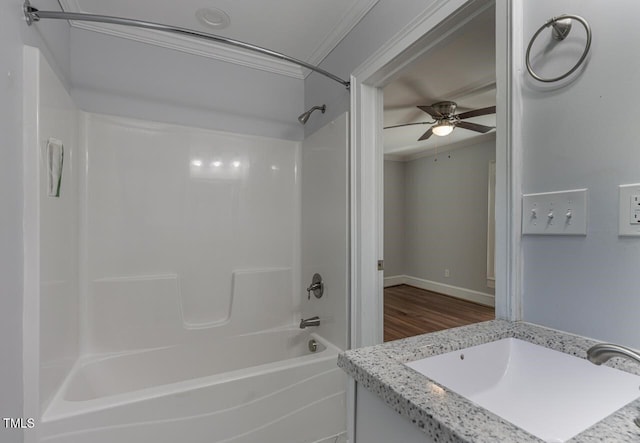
[0,0,69,443]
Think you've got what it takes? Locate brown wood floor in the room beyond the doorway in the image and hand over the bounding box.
[384,285,495,341]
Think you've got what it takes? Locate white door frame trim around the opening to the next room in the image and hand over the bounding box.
[350,0,523,348]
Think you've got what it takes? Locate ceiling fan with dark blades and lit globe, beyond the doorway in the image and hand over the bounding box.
[384,101,496,141]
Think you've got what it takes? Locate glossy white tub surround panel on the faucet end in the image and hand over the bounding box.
[299,113,349,349]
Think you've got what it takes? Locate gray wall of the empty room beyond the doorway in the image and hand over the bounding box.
[384,141,495,294]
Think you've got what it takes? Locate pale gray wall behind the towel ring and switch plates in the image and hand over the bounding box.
[517,0,640,348]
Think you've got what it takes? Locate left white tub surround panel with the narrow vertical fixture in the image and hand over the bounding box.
[22,47,79,441]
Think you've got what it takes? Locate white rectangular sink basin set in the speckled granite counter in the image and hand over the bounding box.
[405,338,640,442]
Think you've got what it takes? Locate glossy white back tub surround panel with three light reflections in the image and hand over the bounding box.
[81,114,300,352]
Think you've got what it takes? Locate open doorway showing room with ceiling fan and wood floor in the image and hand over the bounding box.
[382,6,496,341]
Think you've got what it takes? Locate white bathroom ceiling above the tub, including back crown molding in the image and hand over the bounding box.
[57,0,378,78]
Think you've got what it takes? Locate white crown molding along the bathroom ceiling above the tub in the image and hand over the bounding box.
[59,0,379,80]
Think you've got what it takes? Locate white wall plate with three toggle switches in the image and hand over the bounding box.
[522,189,587,235]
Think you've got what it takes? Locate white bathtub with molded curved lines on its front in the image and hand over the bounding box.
[38,327,346,443]
